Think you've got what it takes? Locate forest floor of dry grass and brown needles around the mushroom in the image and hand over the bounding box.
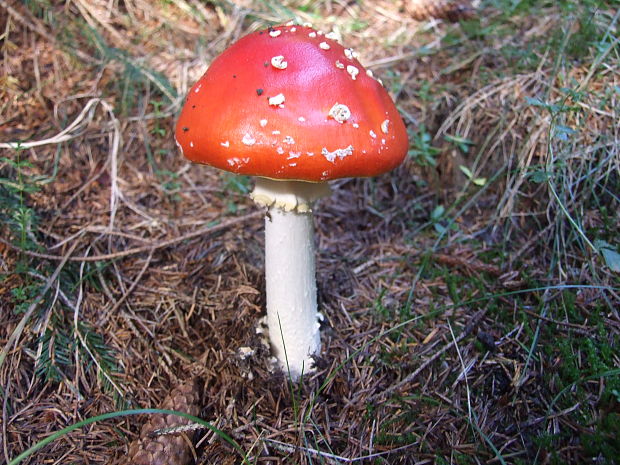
[0,0,620,464]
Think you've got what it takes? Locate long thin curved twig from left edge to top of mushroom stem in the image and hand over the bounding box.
[0,210,264,260]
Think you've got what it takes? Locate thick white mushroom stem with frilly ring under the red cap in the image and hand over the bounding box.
[252,178,330,379]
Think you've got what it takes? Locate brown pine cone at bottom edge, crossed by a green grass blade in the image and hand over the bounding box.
[121,380,200,465]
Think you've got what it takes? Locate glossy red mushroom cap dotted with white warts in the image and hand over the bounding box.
[176,26,408,182]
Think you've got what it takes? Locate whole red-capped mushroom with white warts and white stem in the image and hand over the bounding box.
[176,24,408,378]
